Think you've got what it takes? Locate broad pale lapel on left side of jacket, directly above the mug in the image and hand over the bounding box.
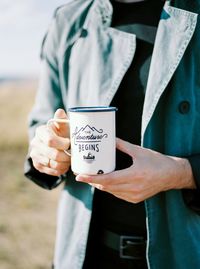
[62,0,136,107]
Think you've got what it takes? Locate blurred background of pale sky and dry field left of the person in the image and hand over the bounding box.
[0,0,69,269]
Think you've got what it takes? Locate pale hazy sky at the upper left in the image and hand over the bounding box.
[0,0,69,78]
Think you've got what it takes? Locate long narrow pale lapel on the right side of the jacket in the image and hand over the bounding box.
[142,1,198,140]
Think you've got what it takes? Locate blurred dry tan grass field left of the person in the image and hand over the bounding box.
[0,82,60,269]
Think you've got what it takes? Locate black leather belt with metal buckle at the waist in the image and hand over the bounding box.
[102,230,146,260]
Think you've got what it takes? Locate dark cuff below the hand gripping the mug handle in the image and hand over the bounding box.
[24,158,64,190]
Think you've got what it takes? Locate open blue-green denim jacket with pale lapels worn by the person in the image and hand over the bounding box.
[25,0,200,269]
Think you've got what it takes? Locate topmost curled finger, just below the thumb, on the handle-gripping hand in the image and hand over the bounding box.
[36,126,70,150]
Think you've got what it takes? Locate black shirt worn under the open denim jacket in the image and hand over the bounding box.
[93,0,164,236]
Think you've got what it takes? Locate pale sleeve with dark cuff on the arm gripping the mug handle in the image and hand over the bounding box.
[24,12,64,189]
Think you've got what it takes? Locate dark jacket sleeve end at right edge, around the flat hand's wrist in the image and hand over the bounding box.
[183,154,200,215]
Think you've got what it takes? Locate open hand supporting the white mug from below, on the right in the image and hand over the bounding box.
[76,139,195,203]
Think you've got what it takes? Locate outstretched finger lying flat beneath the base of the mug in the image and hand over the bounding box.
[76,168,134,186]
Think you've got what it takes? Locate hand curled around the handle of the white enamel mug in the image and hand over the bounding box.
[30,109,70,176]
